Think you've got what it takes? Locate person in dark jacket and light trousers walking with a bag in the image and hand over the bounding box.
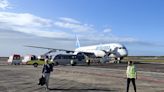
[42,59,53,90]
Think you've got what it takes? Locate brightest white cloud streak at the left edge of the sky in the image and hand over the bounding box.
[0,12,52,27]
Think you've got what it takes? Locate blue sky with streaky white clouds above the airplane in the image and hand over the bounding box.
[0,0,164,56]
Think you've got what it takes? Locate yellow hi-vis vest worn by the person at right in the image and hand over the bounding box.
[126,65,137,78]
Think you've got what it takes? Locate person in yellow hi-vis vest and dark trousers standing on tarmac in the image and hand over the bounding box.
[126,61,137,92]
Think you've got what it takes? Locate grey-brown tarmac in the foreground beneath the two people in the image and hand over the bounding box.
[0,64,164,92]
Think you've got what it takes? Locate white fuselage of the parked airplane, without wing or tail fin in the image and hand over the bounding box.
[74,43,128,58]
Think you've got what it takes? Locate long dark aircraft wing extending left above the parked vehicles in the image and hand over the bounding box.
[25,46,74,53]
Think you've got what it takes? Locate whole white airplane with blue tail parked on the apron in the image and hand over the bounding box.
[26,36,128,63]
